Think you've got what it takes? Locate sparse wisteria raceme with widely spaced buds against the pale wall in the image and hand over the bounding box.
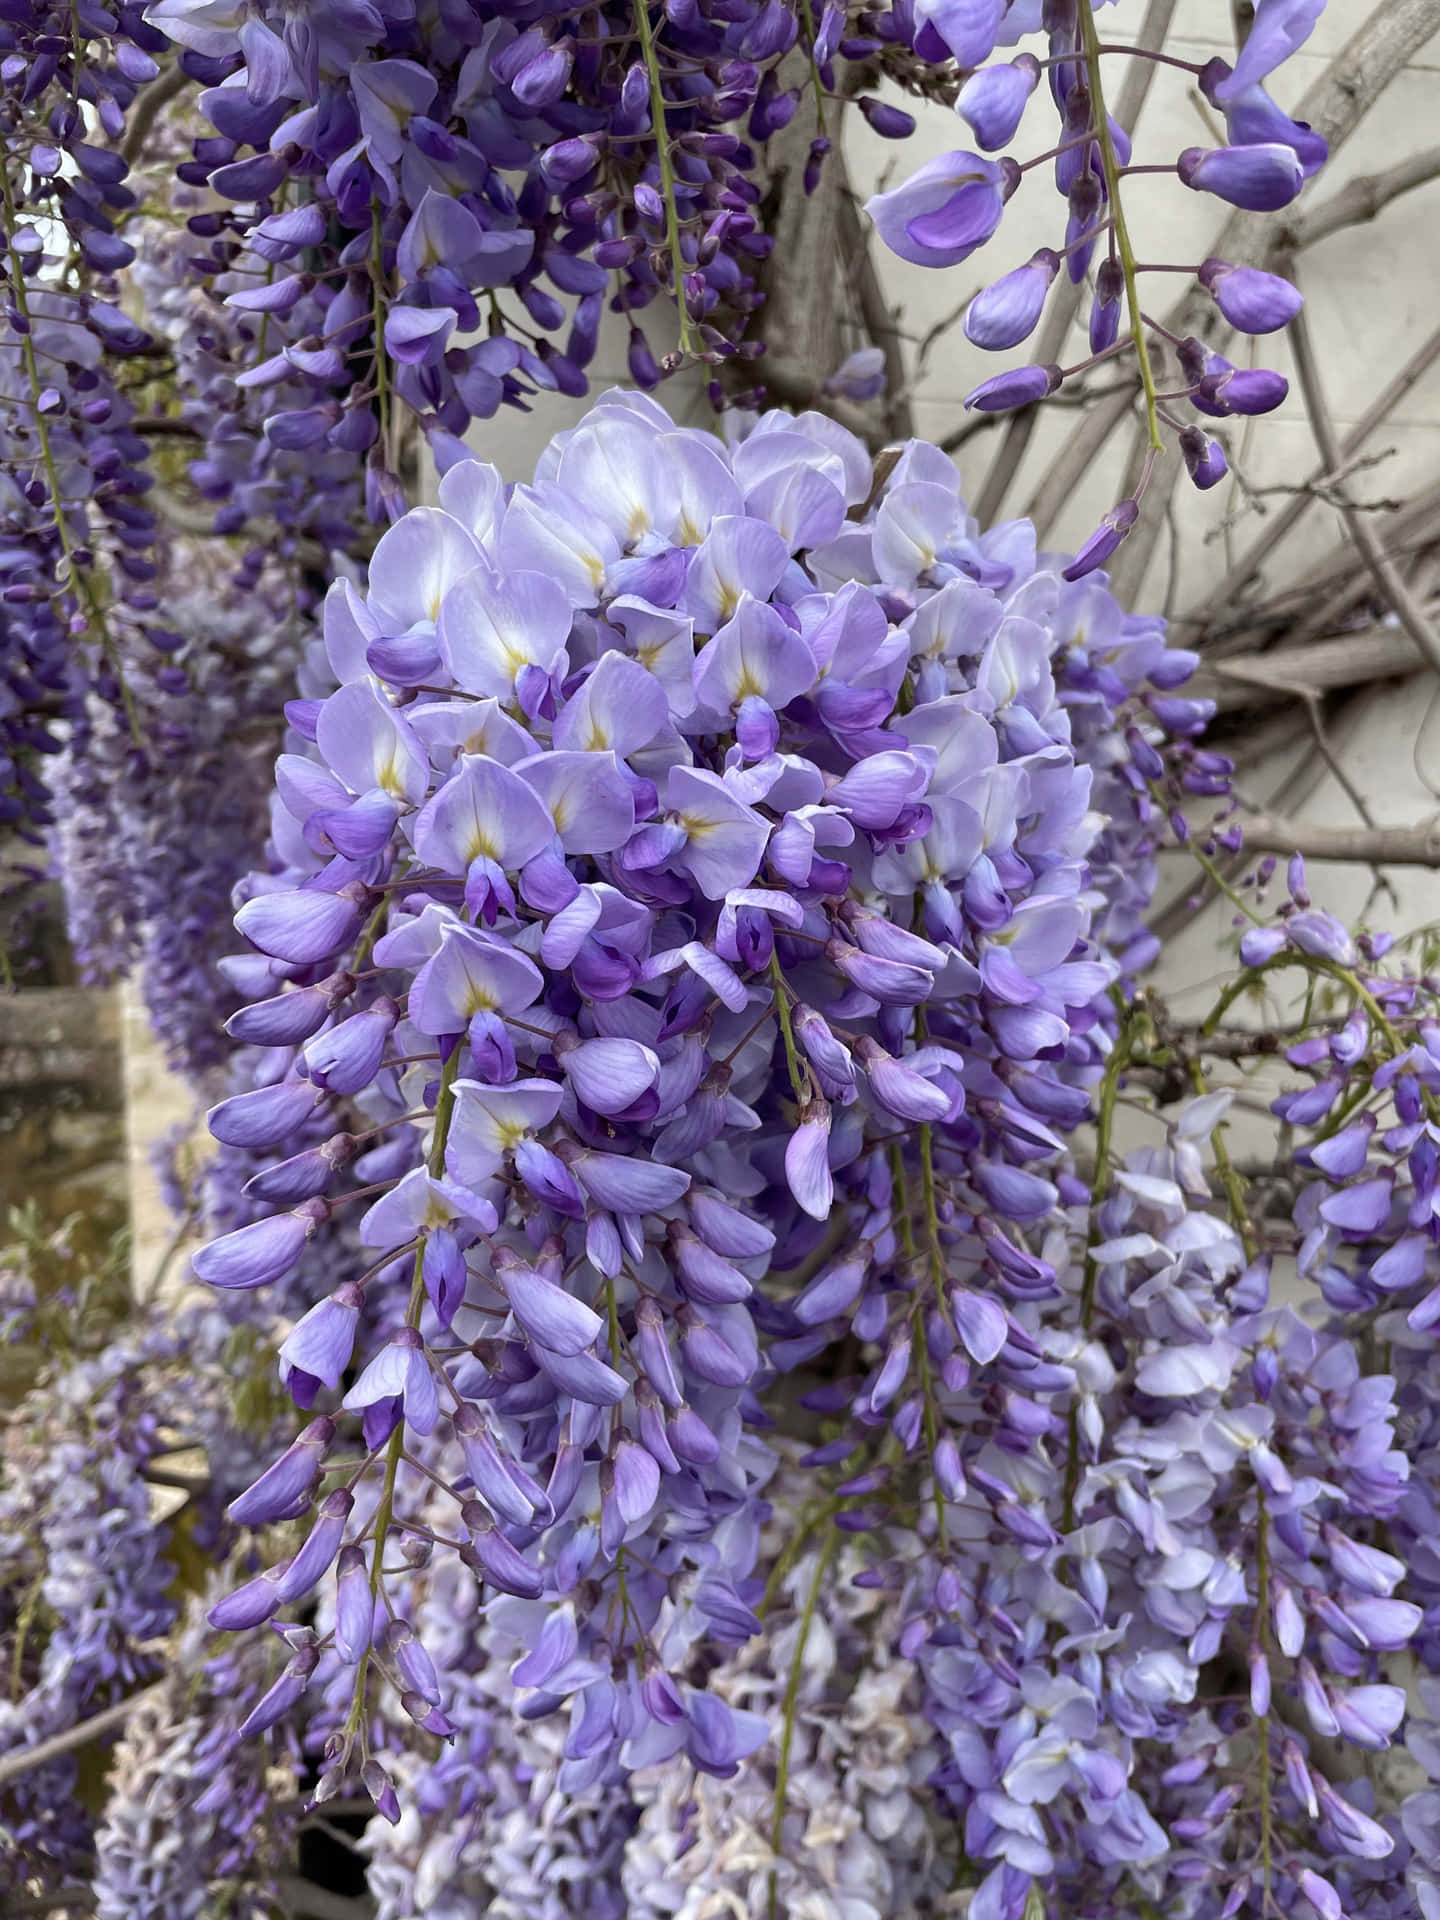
[868,0,1327,566]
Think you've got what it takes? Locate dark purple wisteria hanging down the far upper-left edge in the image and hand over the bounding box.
[0,0,167,831]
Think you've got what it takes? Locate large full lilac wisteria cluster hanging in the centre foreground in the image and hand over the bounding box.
[196,378,1206,1827]
